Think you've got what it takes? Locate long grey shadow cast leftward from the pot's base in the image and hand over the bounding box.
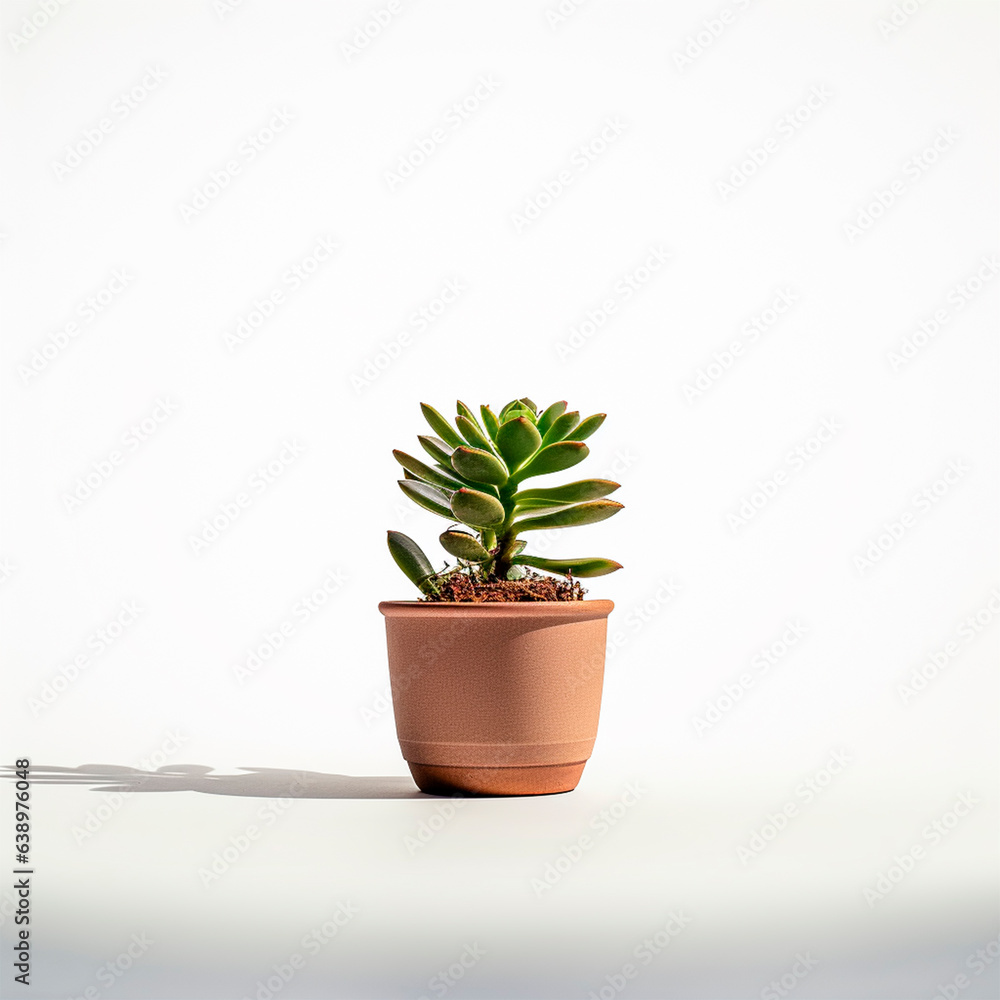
[0,764,425,799]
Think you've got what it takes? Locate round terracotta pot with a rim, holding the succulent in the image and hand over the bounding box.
[378,601,614,795]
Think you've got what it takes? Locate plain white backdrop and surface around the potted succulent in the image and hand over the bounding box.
[0,0,1000,1000]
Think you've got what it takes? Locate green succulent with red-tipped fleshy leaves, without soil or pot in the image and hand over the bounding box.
[389,399,622,595]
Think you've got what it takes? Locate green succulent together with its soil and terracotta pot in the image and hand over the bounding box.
[379,399,622,795]
